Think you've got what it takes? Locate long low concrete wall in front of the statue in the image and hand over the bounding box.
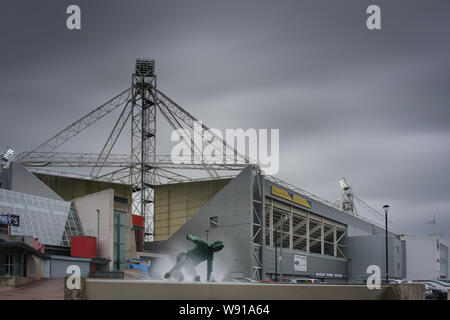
[84,279,425,300]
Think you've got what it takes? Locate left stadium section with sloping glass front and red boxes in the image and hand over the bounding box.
[0,162,143,281]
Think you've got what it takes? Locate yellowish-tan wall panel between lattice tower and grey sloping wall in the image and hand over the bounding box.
[154,179,230,241]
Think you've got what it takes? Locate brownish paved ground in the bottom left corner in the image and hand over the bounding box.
[0,279,64,300]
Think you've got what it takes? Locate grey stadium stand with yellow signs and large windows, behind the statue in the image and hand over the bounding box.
[146,166,406,281]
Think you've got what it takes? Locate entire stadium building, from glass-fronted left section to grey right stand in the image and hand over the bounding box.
[0,163,416,282]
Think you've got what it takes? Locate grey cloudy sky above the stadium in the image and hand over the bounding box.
[0,0,450,238]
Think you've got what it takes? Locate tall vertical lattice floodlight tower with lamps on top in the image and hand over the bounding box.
[130,59,157,241]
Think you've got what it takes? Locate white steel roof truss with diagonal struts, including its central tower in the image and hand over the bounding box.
[17,59,250,240]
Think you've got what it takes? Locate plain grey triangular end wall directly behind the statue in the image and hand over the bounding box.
[146,168,252,280]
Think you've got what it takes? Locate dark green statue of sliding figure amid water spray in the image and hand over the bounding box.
[164,234,224,282]
